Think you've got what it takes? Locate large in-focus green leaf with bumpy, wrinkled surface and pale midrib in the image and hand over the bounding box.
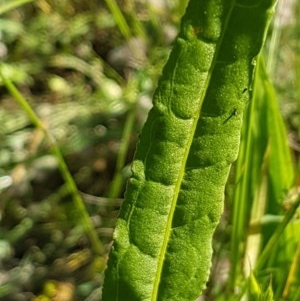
[103,0,276,301]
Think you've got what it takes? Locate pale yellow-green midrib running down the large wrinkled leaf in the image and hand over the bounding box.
[151,0,236,301]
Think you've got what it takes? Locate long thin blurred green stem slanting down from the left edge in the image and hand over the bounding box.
[0,71,104,255]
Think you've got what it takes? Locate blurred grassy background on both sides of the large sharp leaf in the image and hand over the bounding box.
[0,0,300,301]
